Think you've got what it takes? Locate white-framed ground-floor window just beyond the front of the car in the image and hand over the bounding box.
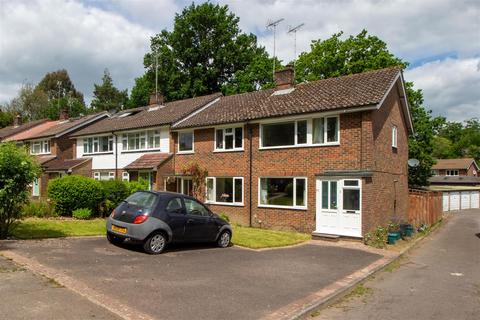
[207,177,243,205]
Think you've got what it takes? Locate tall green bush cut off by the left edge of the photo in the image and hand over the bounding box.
[0,142,40,239]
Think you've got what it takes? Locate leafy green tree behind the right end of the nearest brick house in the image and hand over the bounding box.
[295,30,438,186]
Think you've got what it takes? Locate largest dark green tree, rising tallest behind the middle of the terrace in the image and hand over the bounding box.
[132,2,278,101]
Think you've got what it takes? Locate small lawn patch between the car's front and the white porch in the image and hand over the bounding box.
[232,226,311,249]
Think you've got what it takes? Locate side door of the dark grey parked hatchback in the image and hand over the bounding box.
[183,197,215,242]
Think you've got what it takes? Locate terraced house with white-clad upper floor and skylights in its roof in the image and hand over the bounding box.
[71,94,220,189]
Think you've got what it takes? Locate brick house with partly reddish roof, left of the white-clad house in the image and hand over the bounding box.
[5,112,107,198]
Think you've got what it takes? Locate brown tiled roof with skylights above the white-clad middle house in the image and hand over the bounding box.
[72,93,221,136]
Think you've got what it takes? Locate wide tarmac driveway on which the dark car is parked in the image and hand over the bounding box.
[3,237,381,319]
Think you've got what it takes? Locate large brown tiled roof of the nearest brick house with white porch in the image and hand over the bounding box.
[174,67,401,128]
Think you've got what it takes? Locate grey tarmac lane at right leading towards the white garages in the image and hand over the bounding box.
[314,209,480,320]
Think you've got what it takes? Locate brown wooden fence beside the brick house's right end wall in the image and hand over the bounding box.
[408,189,443,227]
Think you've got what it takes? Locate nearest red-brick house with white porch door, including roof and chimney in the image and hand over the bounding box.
[166,68,413,237]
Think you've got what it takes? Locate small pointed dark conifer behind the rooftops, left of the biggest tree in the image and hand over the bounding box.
[91,69,128,111]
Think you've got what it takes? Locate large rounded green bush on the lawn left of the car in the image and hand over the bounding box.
[48,176,104,215]
